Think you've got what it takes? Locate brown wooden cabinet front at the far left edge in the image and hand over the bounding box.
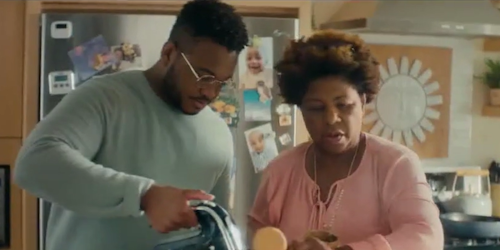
[0,1,25,250]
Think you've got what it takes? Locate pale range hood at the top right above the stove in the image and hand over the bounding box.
[313,0,500,37]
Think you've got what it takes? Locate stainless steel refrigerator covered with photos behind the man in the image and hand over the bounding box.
[39,13,298,249]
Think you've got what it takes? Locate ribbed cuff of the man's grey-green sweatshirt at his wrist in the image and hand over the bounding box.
[123,176,155,217]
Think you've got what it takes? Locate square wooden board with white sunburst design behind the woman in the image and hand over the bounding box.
[363,45,452,158]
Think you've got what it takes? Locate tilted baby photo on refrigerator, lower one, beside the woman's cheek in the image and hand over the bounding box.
[244,123,278,173]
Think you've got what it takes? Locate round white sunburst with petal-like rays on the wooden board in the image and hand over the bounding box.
[364,56,443,147]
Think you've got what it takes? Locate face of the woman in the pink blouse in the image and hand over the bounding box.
[300,77,365,154]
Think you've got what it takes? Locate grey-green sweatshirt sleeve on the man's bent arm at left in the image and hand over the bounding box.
[13,79,153,217]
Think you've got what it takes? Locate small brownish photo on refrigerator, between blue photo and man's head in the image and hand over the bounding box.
[111,43,143,72]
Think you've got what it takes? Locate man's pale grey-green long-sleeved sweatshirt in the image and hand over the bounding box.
[14,71,233,250]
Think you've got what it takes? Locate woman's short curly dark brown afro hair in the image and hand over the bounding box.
[275,30,380,105]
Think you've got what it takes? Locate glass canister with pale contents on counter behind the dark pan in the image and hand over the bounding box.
[442,169,492,216]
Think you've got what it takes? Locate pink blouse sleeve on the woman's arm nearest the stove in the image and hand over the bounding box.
[348,152,444,250]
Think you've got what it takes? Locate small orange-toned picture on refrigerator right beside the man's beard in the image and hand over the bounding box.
[210,94,240,127]
